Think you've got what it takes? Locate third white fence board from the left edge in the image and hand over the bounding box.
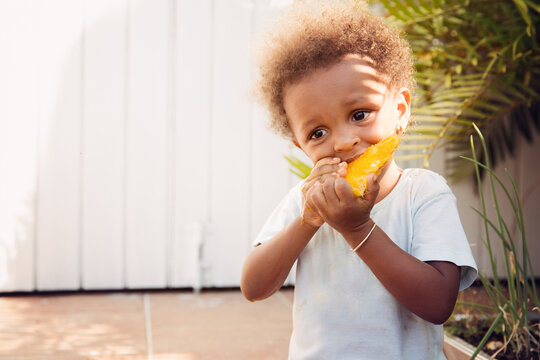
[81,0,127,289]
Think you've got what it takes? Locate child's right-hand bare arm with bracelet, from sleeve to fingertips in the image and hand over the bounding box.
[306,177,460,324]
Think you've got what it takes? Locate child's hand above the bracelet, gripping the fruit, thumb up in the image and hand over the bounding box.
[305,174,379,238]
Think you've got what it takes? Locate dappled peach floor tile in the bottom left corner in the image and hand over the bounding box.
[0,294,147,360]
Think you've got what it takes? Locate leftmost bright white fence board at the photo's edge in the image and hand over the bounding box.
[0,0,38,291]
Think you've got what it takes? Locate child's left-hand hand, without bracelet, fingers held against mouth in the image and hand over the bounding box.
[302,157,347,227]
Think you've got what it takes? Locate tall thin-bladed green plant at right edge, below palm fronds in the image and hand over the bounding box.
[463,123,540,359]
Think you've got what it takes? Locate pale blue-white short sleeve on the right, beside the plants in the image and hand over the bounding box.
[411,175,478,291]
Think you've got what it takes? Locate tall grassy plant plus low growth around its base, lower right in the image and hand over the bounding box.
[440,124,540,359]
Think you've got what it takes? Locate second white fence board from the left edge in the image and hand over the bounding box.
[36,0,83,290]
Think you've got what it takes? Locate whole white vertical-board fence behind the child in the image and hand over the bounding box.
[0,0,540,292]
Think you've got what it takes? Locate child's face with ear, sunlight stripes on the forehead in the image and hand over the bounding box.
[283,55,410,164]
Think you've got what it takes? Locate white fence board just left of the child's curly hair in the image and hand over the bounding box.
[205,0,254,286]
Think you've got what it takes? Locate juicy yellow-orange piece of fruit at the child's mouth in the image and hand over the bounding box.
[345,135,401,197]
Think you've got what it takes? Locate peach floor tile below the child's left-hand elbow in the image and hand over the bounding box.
[150,291,292,360]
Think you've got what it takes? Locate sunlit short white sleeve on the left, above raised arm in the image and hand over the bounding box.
[253,181,304,246]
